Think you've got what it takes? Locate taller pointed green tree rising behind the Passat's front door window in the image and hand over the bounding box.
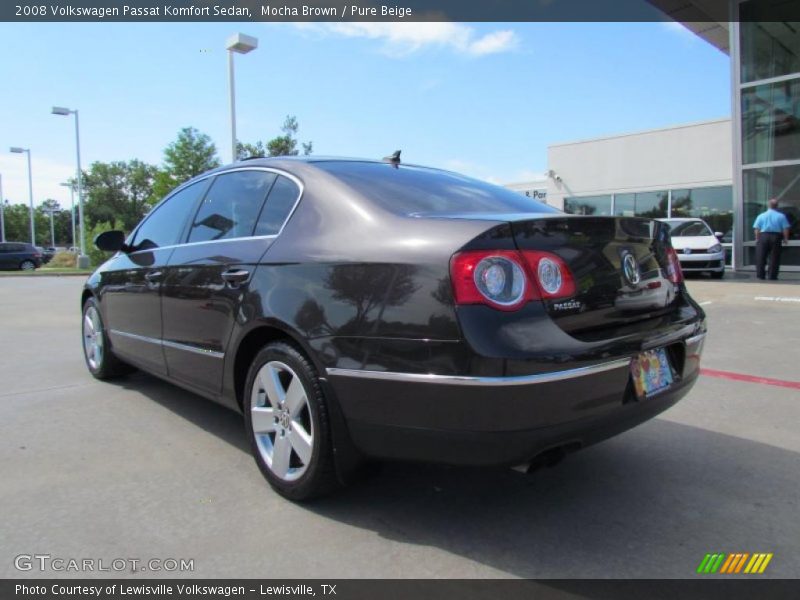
[153,127,220,200]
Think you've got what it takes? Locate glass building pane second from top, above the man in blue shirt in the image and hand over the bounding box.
[742,78,800,164]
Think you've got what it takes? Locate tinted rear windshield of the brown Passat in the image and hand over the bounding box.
[315,161,560,215]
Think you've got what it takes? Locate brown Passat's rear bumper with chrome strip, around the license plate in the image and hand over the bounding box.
[327,334,705,465]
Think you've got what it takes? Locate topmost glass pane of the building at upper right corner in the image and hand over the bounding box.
[739,0,800,83]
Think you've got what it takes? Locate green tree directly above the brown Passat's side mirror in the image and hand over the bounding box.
[82,159,158,232]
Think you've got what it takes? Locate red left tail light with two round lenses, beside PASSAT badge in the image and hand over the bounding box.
[450,250,575,311]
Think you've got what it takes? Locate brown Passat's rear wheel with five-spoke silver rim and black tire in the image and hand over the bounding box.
[247,342,339,501]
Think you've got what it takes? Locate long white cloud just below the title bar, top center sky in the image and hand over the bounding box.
[294,22,519,56]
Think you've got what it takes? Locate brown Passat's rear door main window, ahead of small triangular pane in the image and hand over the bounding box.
[189,171,276,242]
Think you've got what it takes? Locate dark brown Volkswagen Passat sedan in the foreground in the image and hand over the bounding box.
[81,158,706,500]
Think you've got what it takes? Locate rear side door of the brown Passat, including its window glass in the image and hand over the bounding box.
[162,168,301,394]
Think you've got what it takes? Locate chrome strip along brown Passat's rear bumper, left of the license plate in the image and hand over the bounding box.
[326,358,631,387]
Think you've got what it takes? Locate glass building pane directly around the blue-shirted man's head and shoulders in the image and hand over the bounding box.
[744,164,800,246]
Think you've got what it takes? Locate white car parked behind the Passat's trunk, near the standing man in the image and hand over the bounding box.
[659,218,725,279]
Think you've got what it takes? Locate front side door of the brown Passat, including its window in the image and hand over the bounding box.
[101,180,208,374]
